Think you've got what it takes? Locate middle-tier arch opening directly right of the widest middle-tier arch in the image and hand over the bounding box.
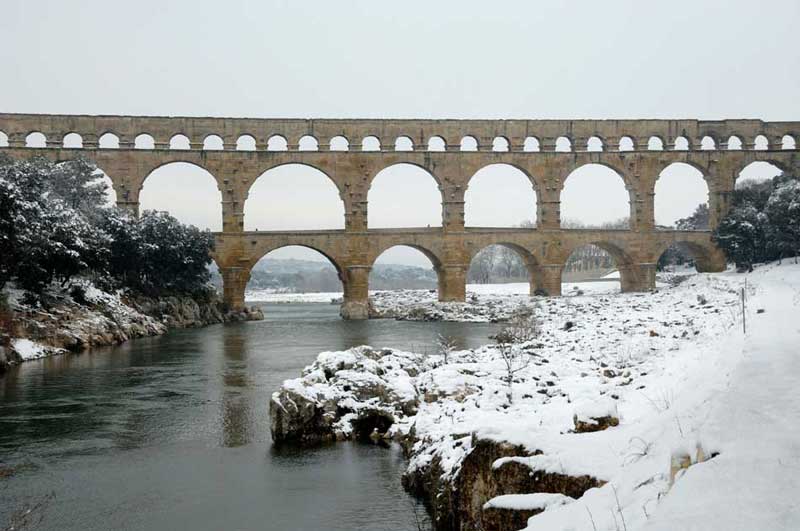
[367,163,443,228]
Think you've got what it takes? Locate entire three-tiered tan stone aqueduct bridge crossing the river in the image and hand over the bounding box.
[0,114,800,319]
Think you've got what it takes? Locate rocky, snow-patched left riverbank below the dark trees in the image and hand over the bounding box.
[0,281,263,371]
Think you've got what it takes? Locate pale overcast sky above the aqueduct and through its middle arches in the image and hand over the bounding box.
[0,0,800,263]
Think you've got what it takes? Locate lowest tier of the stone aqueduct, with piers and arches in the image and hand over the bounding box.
[214,229,726,319]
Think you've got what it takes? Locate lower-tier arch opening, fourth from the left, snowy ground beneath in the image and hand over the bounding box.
[561,245,620,295]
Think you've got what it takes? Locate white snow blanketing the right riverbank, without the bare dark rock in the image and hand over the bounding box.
[276,261,800,531]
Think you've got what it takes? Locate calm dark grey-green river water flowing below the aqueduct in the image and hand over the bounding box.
[0,304,496,531]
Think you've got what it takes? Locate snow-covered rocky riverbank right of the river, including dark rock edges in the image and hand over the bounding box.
[270,264,800,531]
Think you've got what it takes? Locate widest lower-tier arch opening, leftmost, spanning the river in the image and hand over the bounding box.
[245,243,344,301]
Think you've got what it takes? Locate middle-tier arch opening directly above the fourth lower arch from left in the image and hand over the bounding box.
[561,163,632,229]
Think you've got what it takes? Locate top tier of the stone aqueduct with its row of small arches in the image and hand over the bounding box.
[0,114,800,152]
